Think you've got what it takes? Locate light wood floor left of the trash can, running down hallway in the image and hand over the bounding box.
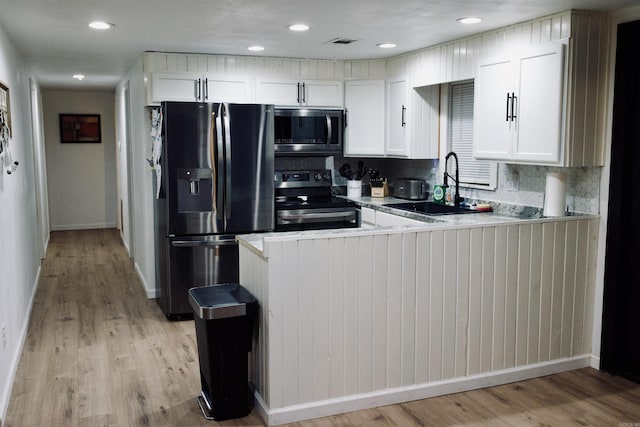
[5,229,263,427]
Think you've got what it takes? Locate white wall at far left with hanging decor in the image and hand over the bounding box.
[0,23,43,424]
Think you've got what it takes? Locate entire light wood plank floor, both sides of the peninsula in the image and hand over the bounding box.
[4,230,640,427]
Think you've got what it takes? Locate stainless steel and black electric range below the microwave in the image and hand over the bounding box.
[275,169,360,231]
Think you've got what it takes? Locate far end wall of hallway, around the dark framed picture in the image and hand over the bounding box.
[42,90,117,230]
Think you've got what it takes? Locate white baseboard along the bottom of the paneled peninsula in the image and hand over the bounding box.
[256,355,591,426]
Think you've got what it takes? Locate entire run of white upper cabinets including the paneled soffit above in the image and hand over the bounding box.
[142,10,612,167]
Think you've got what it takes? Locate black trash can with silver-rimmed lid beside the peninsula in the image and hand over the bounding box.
[189,283,258,421]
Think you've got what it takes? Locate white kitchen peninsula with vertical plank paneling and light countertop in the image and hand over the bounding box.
[238,205,598,425]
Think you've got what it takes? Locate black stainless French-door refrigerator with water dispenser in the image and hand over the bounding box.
[155,102,274,318]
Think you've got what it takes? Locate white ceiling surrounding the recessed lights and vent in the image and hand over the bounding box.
[0,0,638,89]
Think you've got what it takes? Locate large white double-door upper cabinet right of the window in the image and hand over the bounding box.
[474,44,564,165]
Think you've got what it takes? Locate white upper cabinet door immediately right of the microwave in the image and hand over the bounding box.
[344,80,385,157]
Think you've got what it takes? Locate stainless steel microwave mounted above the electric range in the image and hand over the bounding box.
[274,108,344,156]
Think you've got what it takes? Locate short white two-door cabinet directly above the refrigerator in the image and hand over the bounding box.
[147,73,255,105]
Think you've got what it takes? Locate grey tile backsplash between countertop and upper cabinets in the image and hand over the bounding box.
[275,156,602,214]
